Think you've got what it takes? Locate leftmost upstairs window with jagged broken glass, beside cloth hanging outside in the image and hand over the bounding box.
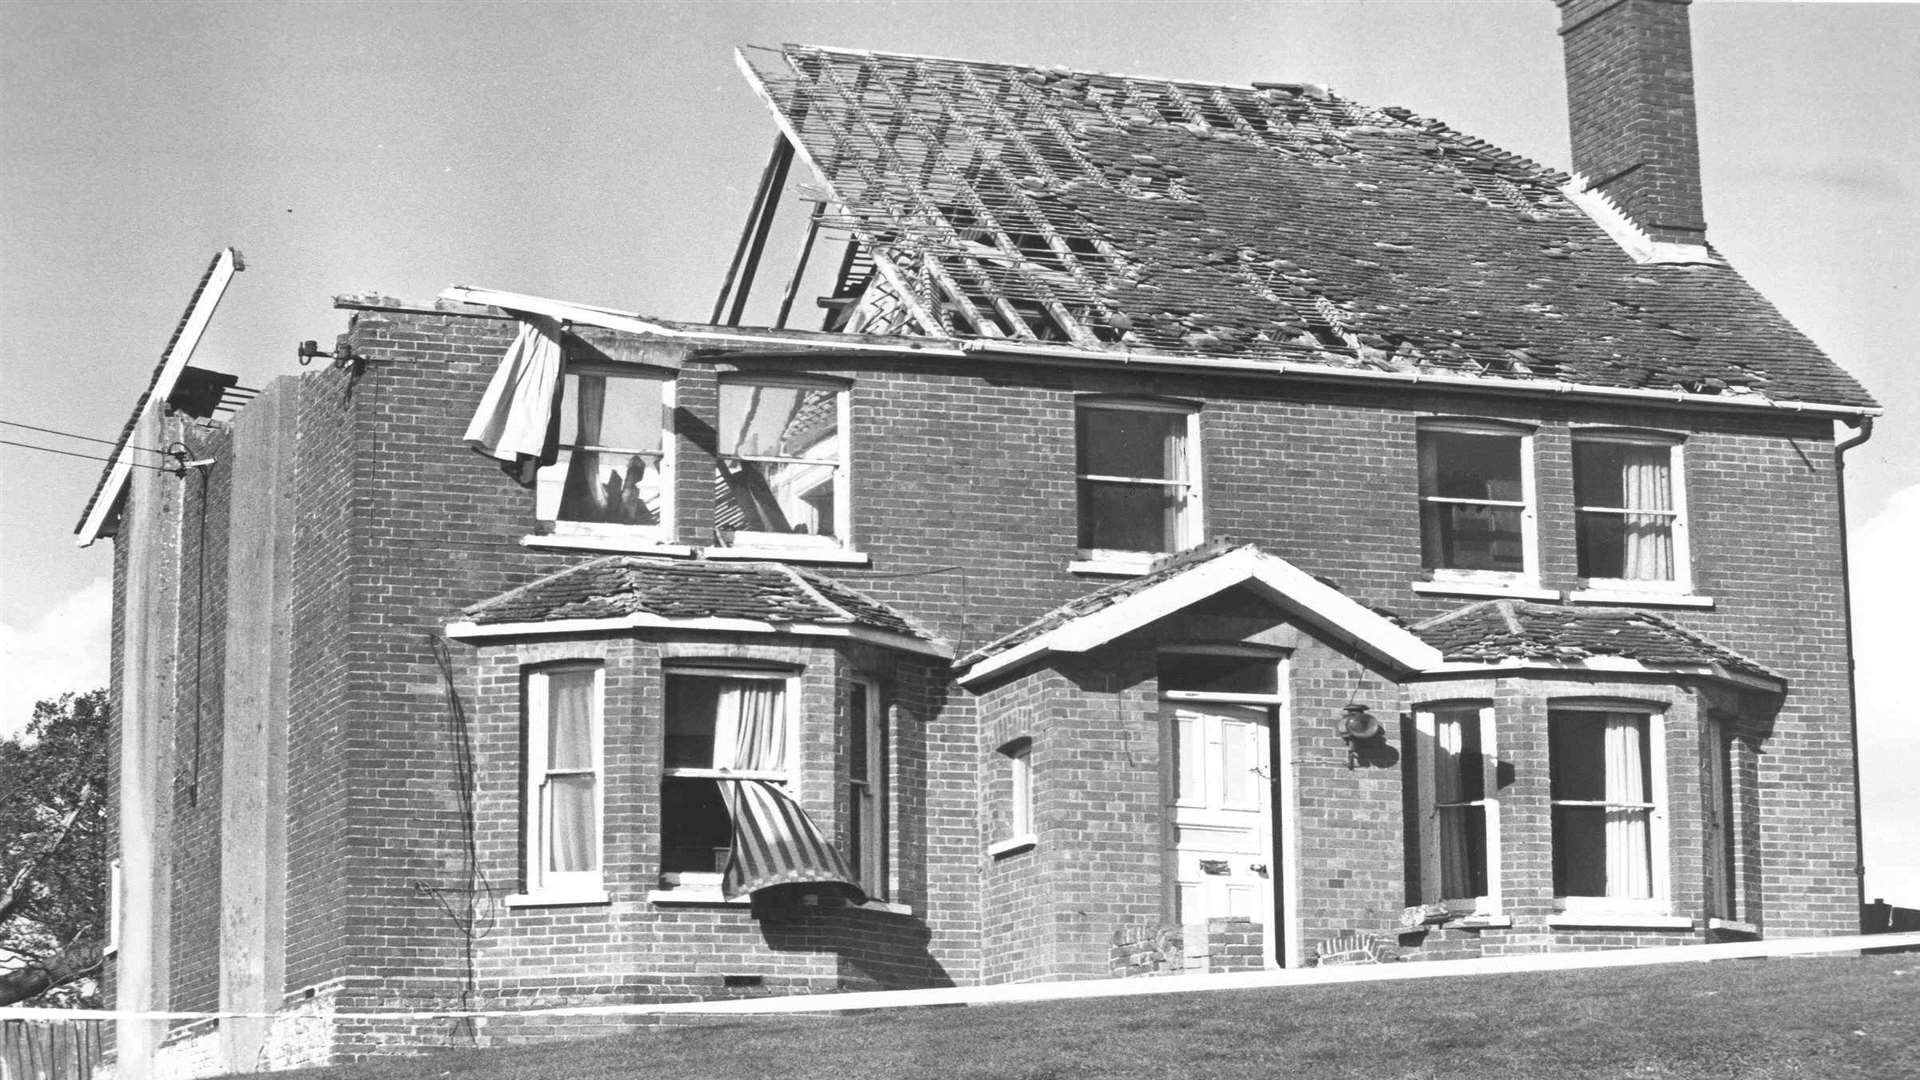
[536,365,674,538]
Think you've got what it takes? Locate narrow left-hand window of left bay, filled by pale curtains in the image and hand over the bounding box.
[524,663,603,899]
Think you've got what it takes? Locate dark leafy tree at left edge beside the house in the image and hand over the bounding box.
[0,690,108,1005]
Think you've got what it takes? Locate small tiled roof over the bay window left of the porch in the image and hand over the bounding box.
[465,555,935,642]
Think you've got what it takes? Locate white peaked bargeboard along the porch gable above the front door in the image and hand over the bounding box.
[960,550,1442,686]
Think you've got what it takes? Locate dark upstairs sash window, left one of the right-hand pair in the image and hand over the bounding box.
[1419,423,1534,578]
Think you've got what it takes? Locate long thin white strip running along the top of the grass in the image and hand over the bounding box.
[0,932,1920,1020]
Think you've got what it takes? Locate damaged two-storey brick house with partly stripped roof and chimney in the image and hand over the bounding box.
[81,0,1878,1068]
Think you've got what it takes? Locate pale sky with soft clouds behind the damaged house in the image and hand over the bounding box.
[0,0,1920,907]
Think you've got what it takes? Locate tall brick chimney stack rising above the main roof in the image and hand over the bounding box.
[1553,0,1707,244]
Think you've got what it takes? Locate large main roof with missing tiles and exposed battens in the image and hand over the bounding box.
[743,46,1872,407]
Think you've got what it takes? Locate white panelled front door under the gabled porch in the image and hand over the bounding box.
[1162,701,1279,963]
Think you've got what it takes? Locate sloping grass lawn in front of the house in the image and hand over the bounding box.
[259,953,1920,1080]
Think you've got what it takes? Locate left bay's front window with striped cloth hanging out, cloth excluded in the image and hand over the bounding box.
[660,669,791,886]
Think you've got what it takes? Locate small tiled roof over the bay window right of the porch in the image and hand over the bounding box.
[1413,600,1786,684]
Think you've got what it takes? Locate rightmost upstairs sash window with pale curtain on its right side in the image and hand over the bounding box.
[1572,432,1686,586]
